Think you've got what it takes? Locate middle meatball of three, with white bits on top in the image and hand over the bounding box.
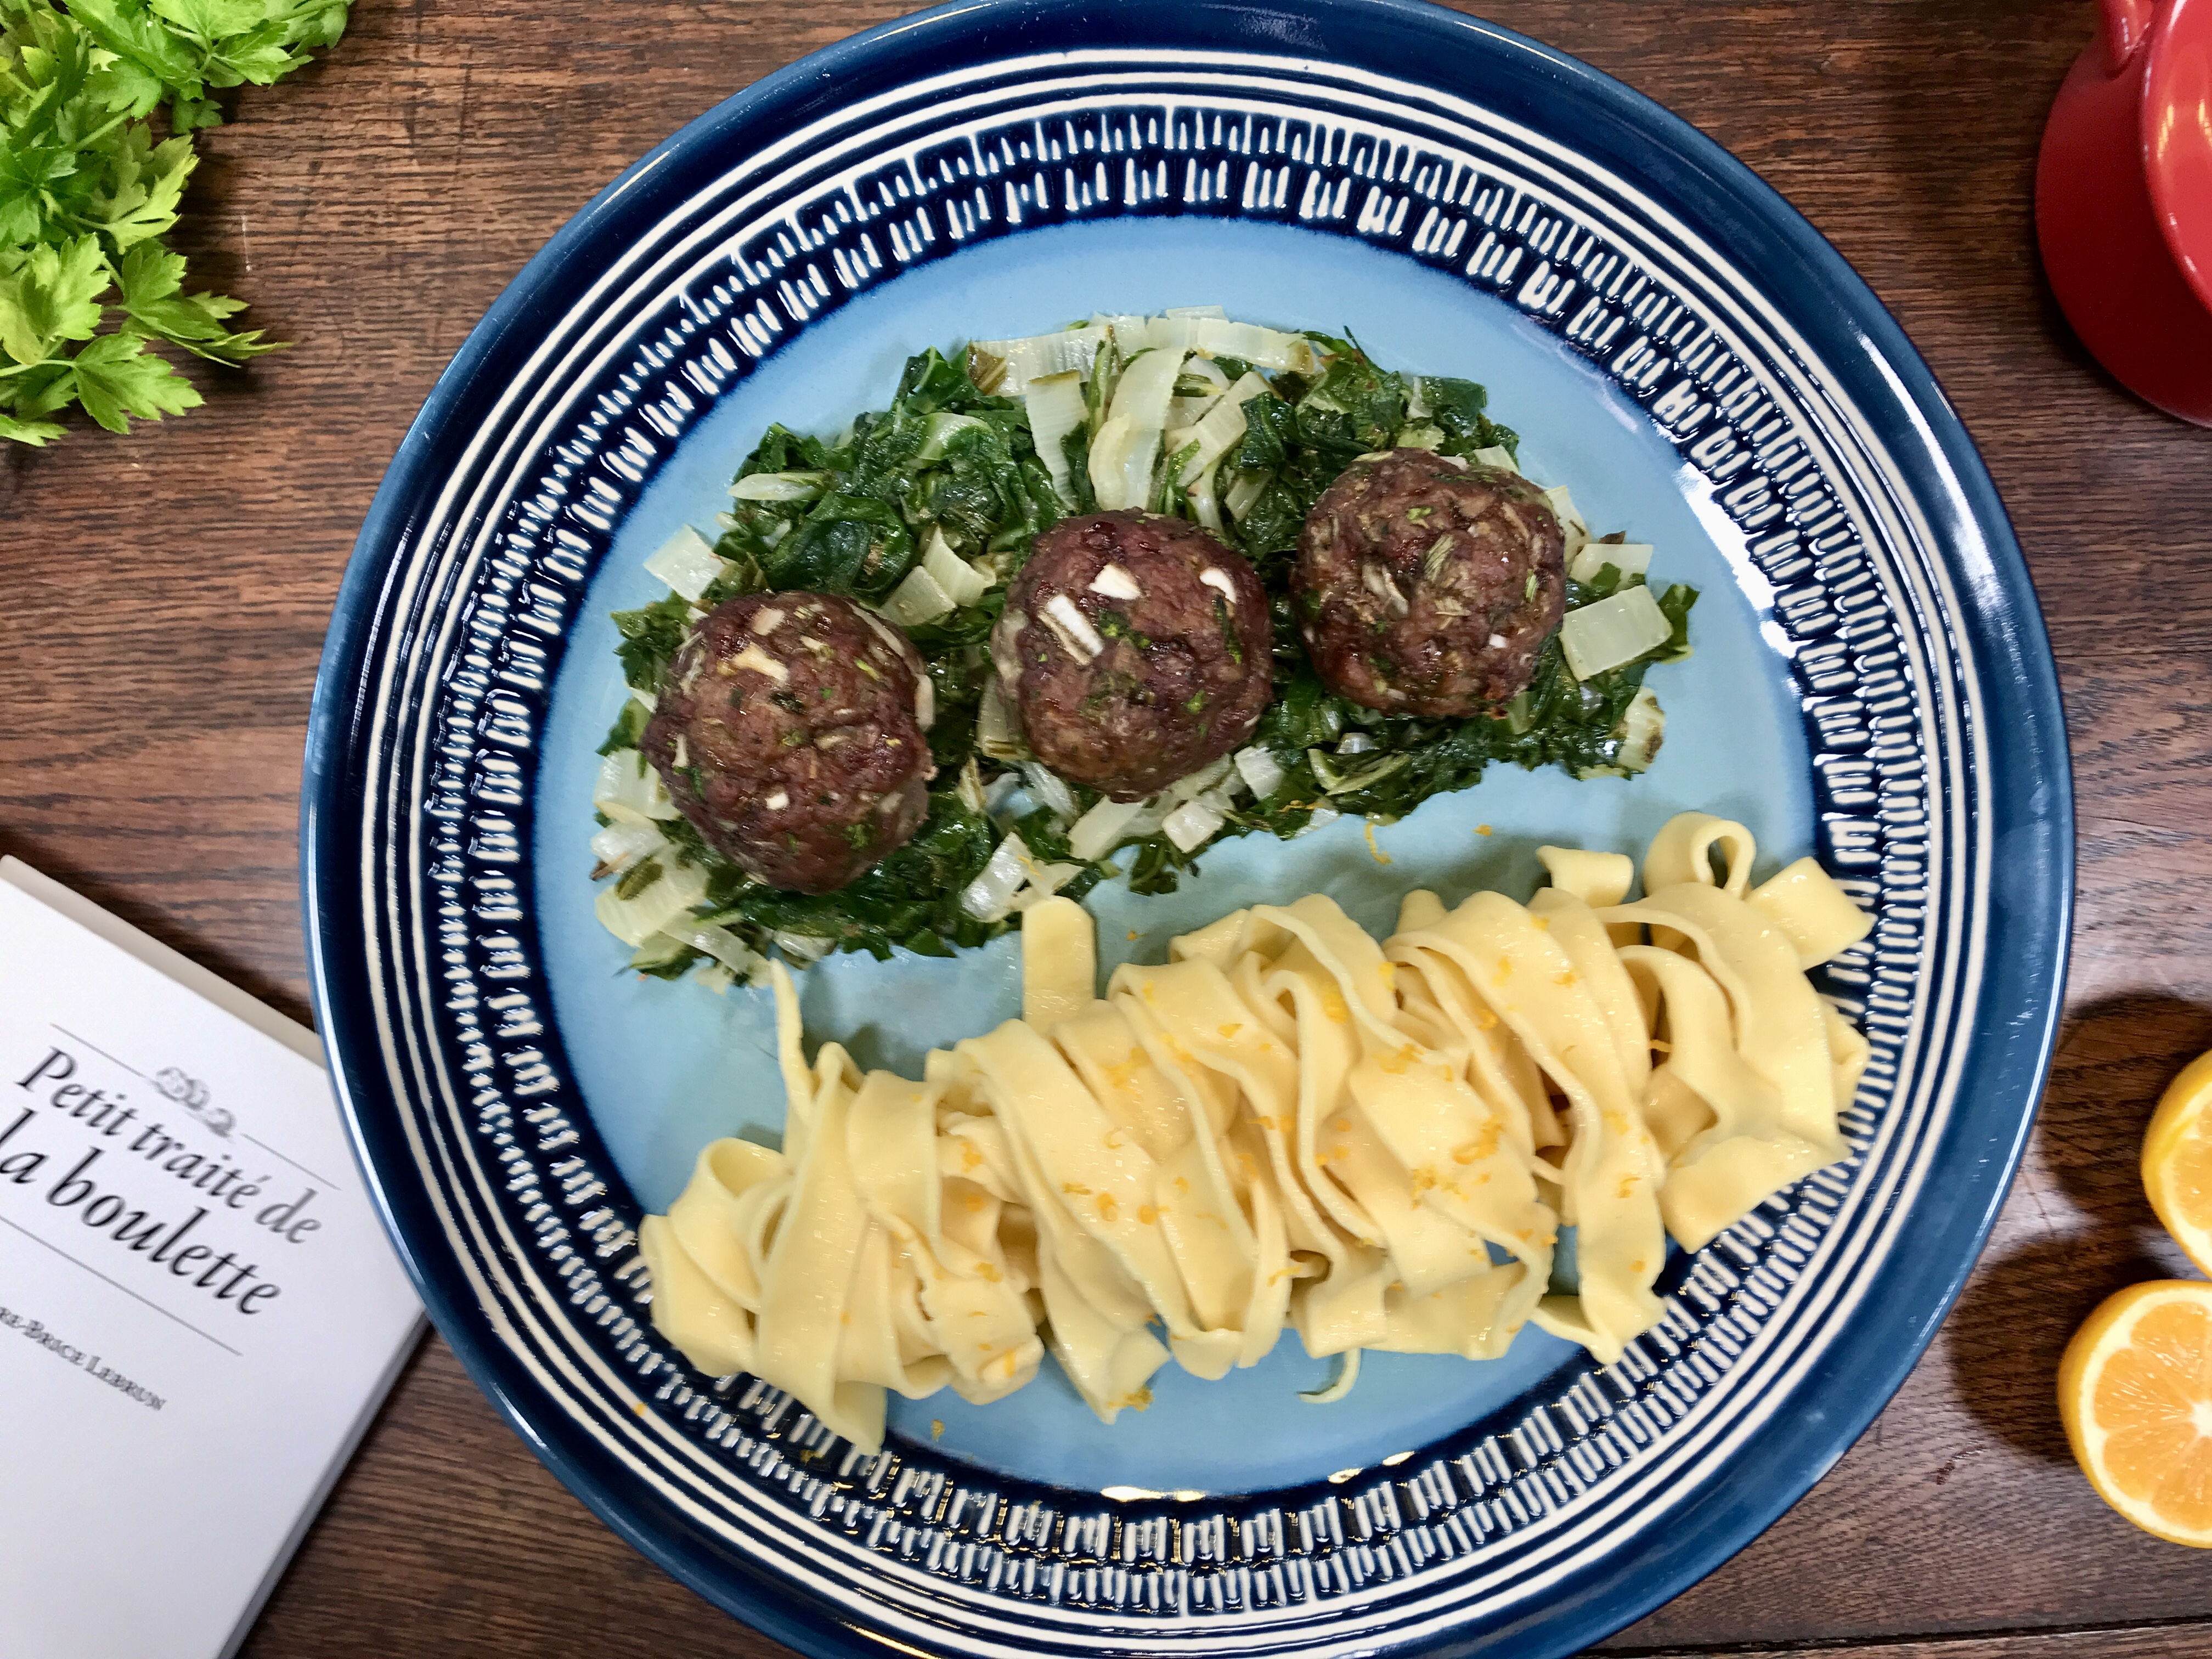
[991,513,1272,801]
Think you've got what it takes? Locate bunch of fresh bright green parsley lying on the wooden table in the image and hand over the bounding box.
[0,0,347,444]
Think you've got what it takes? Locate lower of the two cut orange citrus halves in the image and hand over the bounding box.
[2059,1278,2212,1548]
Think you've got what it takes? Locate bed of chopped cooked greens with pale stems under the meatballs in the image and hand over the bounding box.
[593,312,1697,978]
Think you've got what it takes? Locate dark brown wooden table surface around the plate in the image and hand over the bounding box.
[0,0,2212,1659]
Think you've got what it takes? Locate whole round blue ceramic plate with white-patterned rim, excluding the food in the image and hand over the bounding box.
[303,0,2073,1655]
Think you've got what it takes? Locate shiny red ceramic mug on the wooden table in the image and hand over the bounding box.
[2035,0,2212,427]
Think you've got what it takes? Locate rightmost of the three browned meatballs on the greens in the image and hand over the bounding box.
[1292,449,1566,719]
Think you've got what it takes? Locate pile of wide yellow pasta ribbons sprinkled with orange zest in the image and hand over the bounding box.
[639,812,1871,1449]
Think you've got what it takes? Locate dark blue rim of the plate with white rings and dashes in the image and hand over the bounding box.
[303,0,2073,1657]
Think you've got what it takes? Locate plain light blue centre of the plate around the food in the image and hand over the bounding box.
[533,219,1812,1491]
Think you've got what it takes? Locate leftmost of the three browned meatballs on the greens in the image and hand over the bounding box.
[644,593,936,894]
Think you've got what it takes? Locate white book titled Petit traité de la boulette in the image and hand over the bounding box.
[0,858,422,1659]
